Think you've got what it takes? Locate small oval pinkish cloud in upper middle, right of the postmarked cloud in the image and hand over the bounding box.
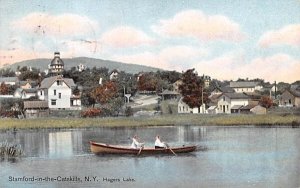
[101,26,154,48]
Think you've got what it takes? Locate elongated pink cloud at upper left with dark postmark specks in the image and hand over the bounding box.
[11,12,98,37]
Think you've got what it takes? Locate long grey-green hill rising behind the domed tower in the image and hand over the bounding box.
[3,57,160,73]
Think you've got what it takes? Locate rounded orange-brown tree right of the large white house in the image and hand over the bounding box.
[91,81,118,104]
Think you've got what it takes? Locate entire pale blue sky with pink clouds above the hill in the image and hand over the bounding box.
[0,0,300,83]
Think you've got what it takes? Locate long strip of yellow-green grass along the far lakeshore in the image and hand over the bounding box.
[0,114,300,129]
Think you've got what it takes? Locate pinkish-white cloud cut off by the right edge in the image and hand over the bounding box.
[258,24,300,48]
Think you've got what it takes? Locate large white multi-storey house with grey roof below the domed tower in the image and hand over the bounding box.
[38,75,81,109]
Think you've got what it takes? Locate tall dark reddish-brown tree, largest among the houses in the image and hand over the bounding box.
[179,69,208,108]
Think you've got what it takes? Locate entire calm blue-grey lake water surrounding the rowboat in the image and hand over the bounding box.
[0,126,300,188]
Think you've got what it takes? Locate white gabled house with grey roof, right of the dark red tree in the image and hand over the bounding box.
[217,93,250,114]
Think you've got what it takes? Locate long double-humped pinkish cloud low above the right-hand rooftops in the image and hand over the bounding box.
[195,53,300,83]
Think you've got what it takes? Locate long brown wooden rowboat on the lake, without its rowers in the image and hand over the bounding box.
[90,141,197,155]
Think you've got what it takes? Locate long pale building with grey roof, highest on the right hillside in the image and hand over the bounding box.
[230,81,262,93]
